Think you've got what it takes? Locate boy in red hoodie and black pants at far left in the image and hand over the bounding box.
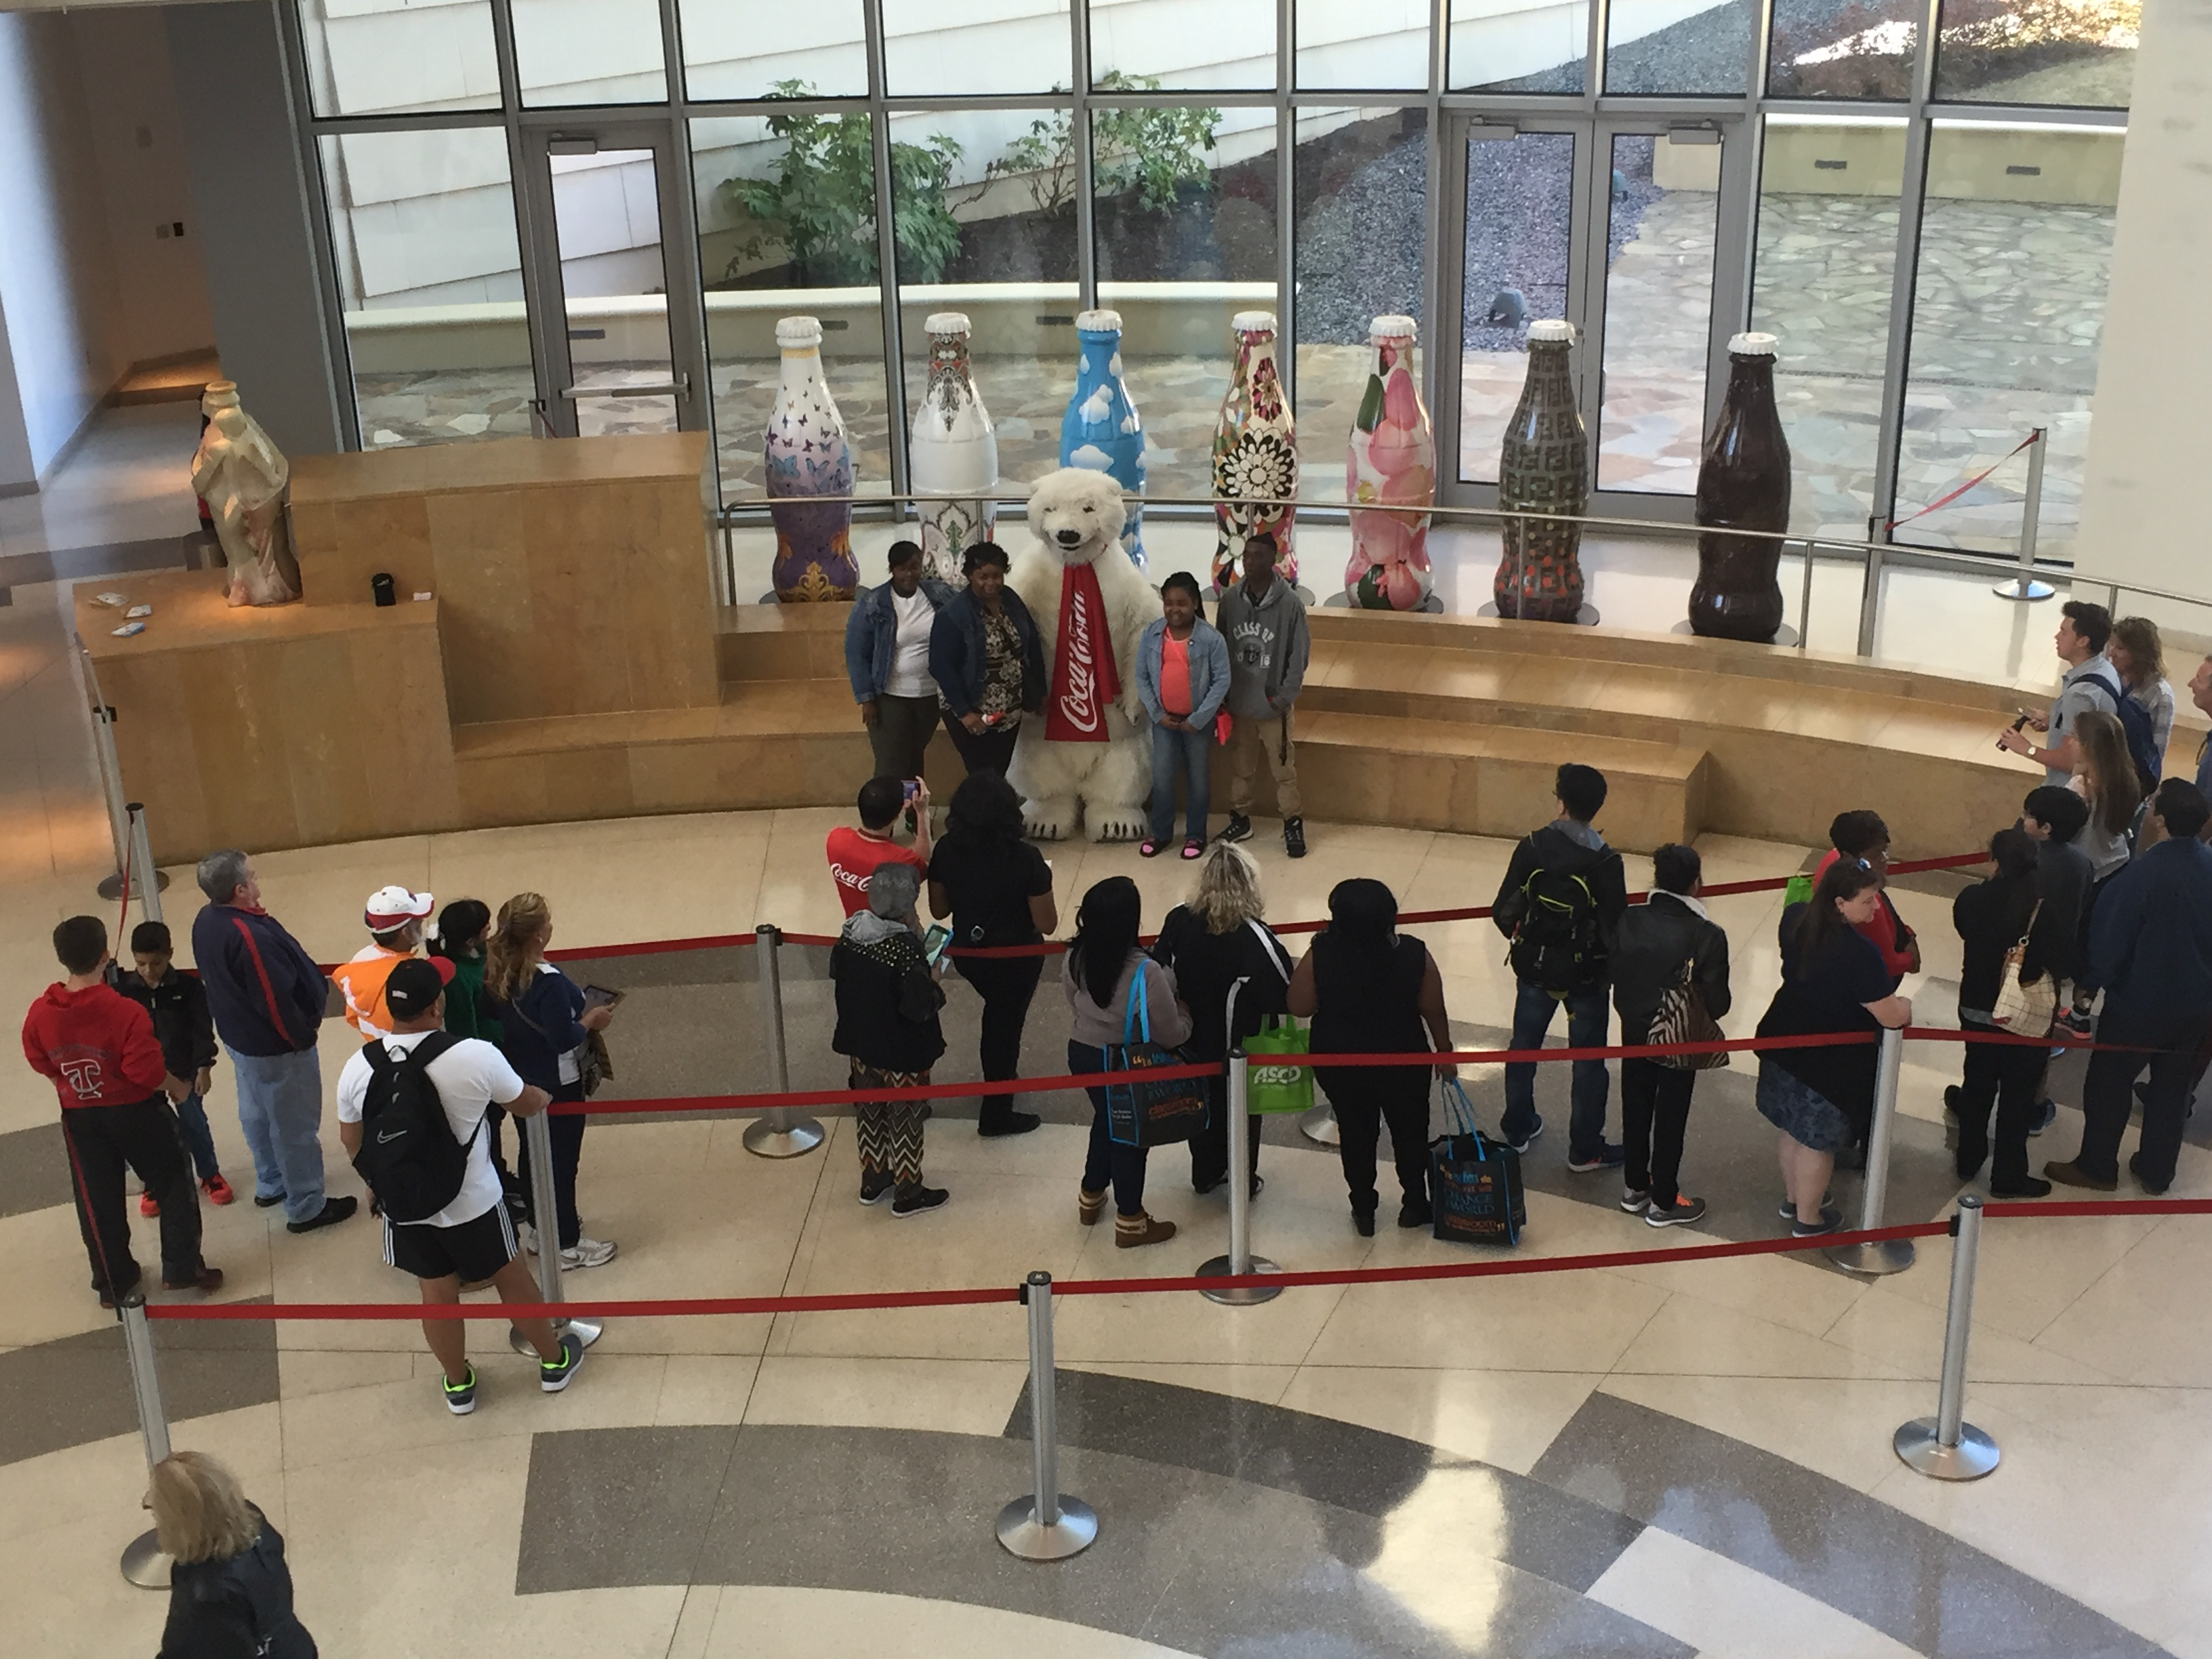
[22,916,224,1307]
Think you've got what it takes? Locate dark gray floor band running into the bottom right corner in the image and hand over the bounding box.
[1533,1393,2159,1659]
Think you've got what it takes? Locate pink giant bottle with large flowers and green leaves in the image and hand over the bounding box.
[1345,316,1435,611]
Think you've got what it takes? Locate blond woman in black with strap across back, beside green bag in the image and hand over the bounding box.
[1153,840,1290,1197]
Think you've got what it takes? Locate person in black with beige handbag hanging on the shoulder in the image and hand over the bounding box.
[1942,830,2051,1199]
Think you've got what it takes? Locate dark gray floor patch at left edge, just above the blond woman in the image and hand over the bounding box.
[0,1292,276,1465]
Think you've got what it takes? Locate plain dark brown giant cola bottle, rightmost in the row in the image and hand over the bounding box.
[1690,334,1790,639]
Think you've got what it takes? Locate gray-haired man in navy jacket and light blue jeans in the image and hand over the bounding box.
[192,847,361,1232]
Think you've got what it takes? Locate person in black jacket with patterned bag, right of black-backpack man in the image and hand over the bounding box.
[1610,843,1729,1228]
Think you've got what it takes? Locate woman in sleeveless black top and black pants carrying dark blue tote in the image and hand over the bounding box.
[1285,876,1460,1239]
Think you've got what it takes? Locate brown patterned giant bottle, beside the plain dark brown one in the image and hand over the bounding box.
[1493,321,1591,621]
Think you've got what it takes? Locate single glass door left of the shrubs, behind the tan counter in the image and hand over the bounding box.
[525,119,708,438]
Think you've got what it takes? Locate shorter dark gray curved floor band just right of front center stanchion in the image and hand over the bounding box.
[1006,1372,1643,1595]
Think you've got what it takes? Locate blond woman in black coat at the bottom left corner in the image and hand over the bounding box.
[146,1451,316,1659]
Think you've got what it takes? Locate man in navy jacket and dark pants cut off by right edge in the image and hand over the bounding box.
[2044,779,2212,1197]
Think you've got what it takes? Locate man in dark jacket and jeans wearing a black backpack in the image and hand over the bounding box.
[1491,761,1628,1174]
